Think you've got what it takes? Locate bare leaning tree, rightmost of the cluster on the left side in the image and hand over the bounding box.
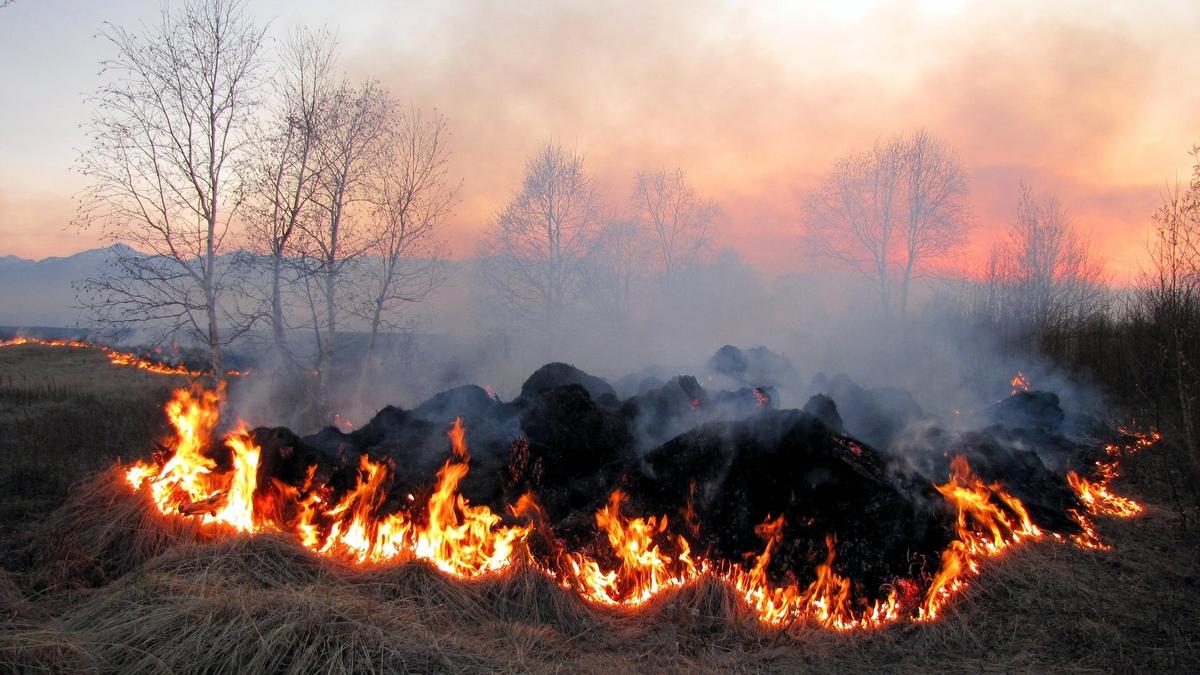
[358,108,456,386]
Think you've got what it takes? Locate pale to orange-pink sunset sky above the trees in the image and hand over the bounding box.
[0,0,1200,282]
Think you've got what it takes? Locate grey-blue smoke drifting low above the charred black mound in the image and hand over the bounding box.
[220,233,1104,468]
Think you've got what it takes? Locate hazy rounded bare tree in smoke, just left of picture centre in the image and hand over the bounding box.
[480,143,601,345]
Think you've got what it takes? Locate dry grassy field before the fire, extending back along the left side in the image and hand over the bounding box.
[0,346,1200,673]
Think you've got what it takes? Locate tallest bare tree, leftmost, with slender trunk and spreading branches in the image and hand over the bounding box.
[78,0,263,374]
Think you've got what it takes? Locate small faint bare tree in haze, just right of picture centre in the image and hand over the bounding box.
[634,169,718,285]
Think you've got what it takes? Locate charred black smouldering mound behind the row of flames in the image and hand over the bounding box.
[211,348,1118,597]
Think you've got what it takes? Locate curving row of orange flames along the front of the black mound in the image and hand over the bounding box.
[125,387,1145,631]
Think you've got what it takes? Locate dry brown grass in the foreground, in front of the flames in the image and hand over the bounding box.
[0,343,1200,673]
